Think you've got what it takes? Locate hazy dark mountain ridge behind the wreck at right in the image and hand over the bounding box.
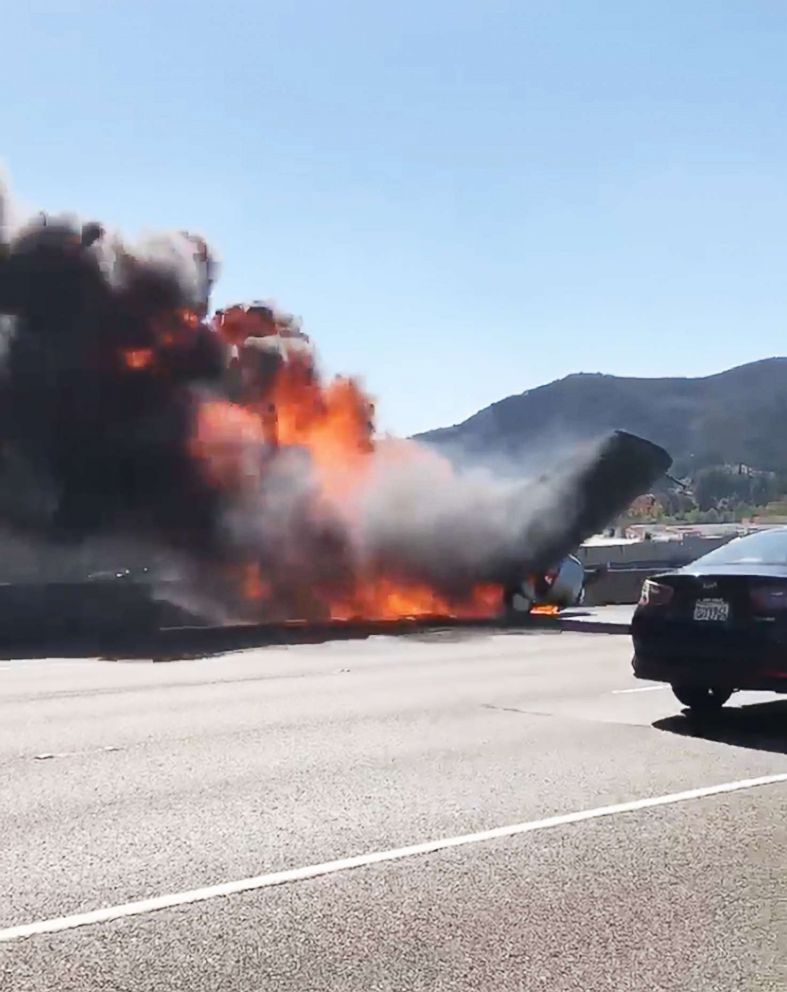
[416,356,787,473]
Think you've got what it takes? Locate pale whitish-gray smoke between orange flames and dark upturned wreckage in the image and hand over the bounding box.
[209,424,592,600]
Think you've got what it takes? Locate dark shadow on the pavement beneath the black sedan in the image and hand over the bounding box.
[653,699,787,754]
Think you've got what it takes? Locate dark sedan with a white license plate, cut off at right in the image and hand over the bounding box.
[631,527,787,711]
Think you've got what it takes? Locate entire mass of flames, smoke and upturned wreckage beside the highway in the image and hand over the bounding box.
[0,198,670,637]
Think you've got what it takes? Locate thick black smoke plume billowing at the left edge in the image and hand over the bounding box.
[0,197,223,547]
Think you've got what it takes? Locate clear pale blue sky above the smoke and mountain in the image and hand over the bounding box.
[0,0,787,432]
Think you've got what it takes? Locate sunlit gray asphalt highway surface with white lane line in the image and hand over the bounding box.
[0,630,787,992]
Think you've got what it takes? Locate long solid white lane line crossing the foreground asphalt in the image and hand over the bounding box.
[0,772,787,943]
